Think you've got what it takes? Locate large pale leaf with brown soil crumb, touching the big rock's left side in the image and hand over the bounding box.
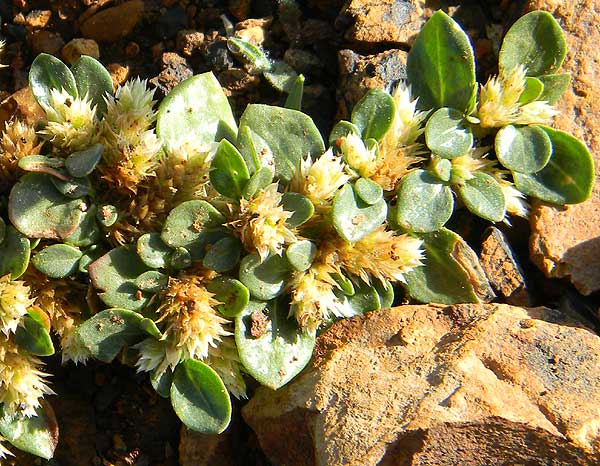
[235,301,315,390]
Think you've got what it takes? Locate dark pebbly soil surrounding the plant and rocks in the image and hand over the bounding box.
[0,0,597,466]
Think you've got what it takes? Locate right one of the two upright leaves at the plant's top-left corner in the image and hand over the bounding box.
[71,55,113,116]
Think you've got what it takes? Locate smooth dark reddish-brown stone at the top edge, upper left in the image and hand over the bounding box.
[81,0,144,42]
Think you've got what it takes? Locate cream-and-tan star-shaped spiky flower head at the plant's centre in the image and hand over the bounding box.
[237,183,297,259]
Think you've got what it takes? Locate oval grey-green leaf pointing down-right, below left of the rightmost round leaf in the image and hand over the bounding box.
[458,173,506,222]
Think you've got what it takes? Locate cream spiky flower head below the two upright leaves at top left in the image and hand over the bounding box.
[40,89,98,152]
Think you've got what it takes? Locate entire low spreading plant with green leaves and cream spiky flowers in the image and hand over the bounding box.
[0,12,594,458]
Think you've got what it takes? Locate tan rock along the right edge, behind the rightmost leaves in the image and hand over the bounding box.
[527,0,600,295]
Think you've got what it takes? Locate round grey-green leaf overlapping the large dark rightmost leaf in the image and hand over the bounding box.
[495,125,552,173]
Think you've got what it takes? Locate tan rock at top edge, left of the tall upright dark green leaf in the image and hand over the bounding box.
[335,0,425,50]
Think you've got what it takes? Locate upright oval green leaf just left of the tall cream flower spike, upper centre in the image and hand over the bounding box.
[351,89,395,141]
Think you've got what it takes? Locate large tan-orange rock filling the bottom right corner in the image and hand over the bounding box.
[242,304,600,466]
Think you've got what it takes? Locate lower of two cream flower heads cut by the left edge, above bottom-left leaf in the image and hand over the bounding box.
[0,337,54,417]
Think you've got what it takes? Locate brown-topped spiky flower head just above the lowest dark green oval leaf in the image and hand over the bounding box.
[157,275,230,359]
